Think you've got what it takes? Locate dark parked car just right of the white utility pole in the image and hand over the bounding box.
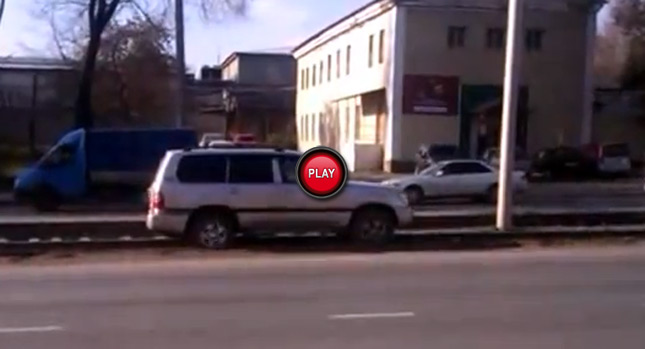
[529,146,598,180]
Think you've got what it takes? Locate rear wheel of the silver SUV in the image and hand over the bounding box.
[186,212,235,250]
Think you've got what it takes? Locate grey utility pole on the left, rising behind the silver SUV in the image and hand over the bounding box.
[175,0,186,127]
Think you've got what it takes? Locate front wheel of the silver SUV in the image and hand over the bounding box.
[350,208,395,247]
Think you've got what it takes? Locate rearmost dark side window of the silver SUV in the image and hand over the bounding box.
[177,154,226,183]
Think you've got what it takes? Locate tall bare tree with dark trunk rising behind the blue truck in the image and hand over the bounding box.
[39,0,251,128]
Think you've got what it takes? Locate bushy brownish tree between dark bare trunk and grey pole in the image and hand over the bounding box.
[92,17,174,124]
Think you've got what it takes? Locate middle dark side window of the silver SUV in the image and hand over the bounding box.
[228,154,273,184]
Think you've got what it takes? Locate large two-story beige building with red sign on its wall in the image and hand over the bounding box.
[293,0,604,171]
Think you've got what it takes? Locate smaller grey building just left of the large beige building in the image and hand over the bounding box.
[221,52,296,140]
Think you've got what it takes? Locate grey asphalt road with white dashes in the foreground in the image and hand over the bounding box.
[0,246,645,349]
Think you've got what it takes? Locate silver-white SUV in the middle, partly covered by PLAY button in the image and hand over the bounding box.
[146,147,412,249]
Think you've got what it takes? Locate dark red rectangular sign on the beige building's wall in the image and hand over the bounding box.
[403,75,459,115]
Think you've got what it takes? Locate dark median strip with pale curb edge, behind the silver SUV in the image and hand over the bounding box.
[0,209,645,242]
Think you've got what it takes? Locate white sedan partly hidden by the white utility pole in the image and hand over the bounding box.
[383,160,527,204]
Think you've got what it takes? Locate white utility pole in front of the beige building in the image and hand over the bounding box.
[496,0,524,231]
